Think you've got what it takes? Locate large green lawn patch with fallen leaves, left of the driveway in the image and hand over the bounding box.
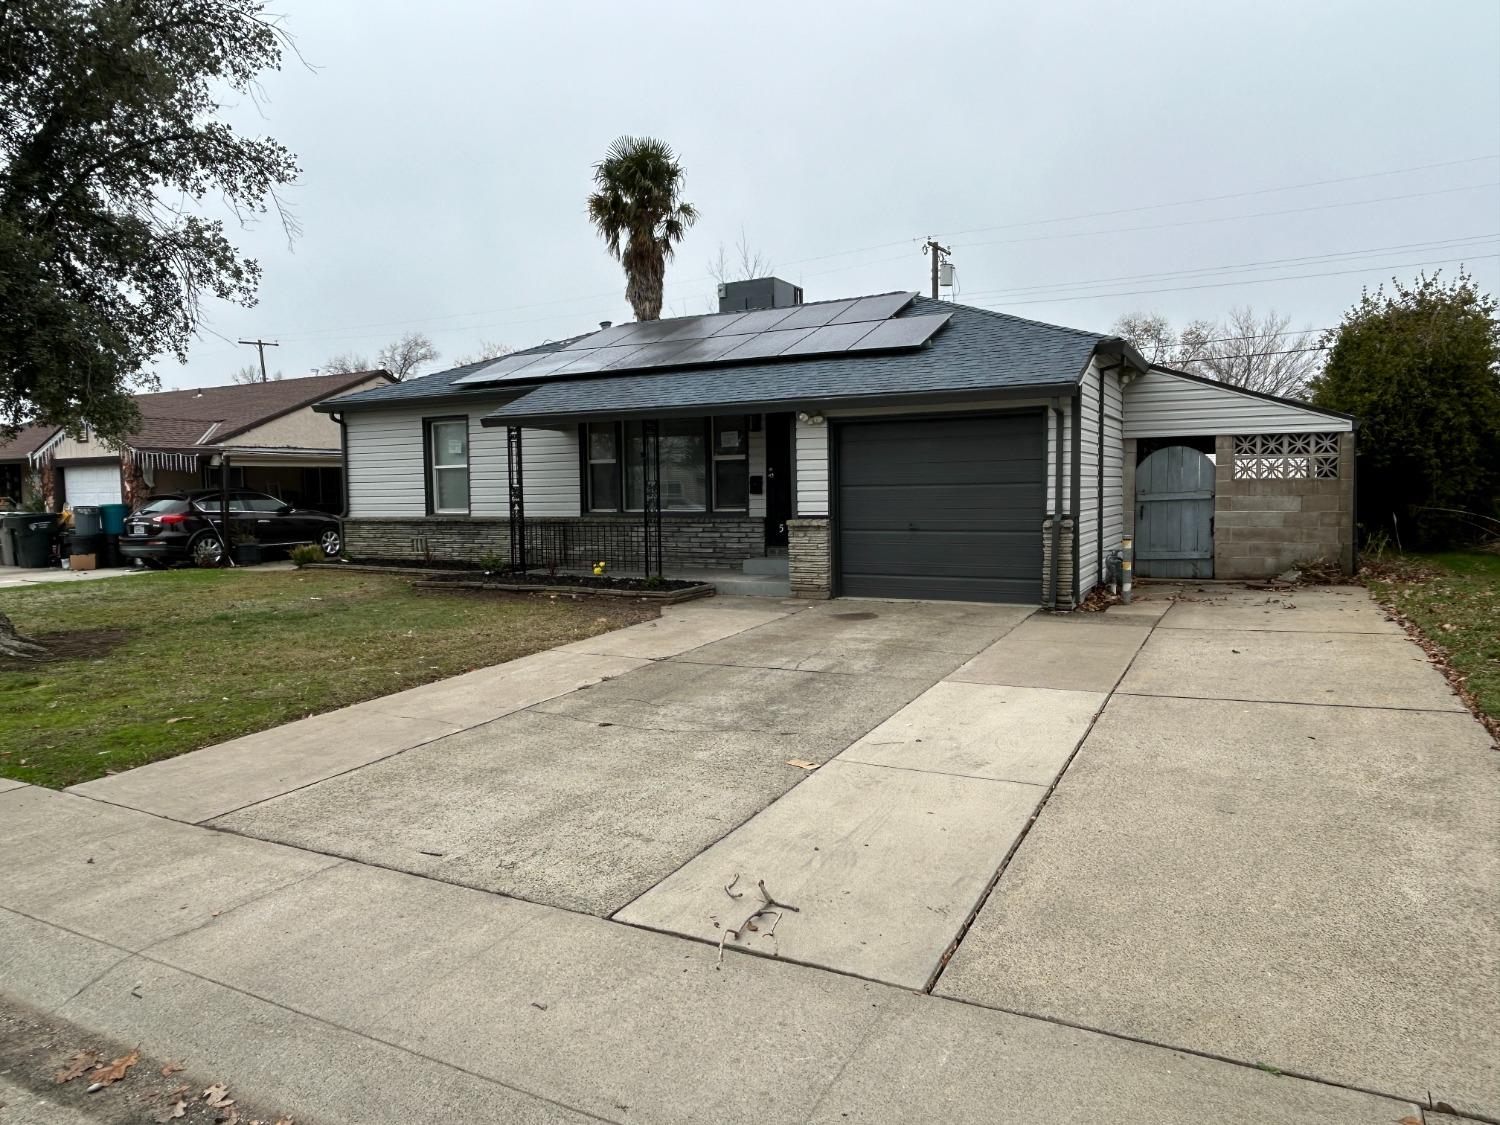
[0,570,657,788]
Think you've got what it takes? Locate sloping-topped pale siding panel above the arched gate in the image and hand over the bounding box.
[1125,371,1353,438]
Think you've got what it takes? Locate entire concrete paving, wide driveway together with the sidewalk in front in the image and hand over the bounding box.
[0,587,1500,1125]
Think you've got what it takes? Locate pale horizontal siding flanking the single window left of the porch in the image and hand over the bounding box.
[345,404,579,519]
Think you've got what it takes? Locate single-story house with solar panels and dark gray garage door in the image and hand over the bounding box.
[318,279,1353,605]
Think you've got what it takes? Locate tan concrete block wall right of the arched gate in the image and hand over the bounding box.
[1214,434,1355,578]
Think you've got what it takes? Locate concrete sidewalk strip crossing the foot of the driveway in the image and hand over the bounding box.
[0,788,1418,1125]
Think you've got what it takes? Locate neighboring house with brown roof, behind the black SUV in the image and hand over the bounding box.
[30,371,393,512]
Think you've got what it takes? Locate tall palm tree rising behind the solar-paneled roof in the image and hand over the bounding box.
[588,137,698,321]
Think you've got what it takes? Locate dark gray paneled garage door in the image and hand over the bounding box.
[834,413,1047,602]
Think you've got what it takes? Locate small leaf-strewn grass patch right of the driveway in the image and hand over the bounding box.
[1370,551,1500,719]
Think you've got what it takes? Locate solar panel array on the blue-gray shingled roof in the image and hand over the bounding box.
[455,293,953,386]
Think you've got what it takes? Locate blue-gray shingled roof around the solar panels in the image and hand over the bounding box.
[318,297,1145,425]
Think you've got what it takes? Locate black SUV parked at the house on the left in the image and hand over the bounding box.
[120,489,344,567]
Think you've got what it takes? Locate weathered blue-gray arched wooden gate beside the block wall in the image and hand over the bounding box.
[1136,446,1214,578]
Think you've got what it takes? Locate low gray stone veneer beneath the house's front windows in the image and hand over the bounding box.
[344,515,765,570]
